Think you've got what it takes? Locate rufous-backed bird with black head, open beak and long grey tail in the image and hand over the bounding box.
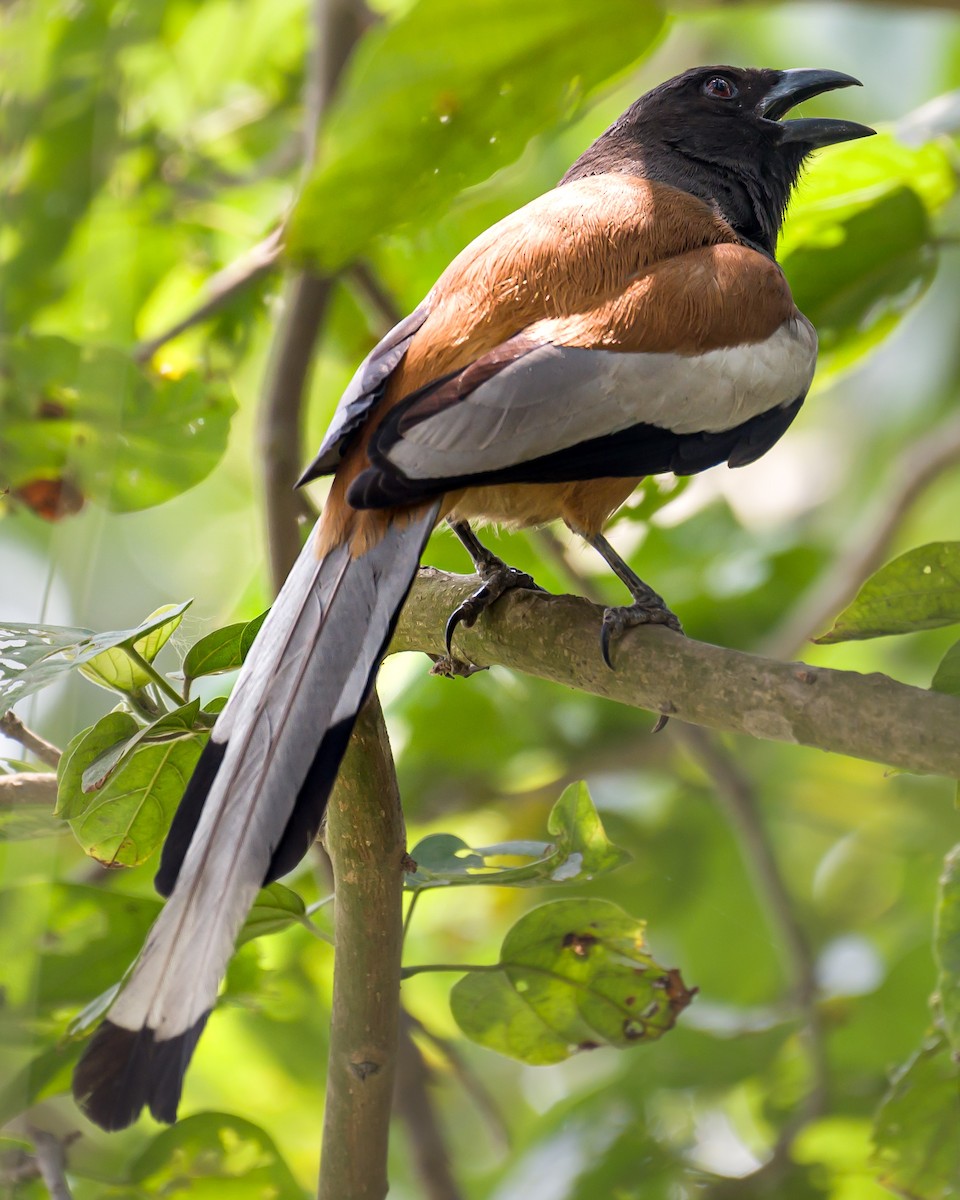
[73,66,874,1130]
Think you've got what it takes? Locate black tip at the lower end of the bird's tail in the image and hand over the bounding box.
[73,1013,210,1133]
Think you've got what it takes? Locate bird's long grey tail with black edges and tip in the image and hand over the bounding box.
[73,505,439,1129]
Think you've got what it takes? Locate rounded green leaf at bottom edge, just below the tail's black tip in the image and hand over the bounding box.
[130,1112,307,1200]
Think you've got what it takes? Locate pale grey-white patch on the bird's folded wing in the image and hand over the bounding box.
[364,314,816,489]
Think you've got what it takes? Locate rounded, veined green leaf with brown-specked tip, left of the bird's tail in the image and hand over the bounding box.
[58,702,208,866]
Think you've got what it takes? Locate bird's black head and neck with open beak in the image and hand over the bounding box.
[563,66,874,254]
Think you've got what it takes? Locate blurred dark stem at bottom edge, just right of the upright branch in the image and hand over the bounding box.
[394,1008,463,1200]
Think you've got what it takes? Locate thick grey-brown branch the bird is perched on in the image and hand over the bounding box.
[392,568,960,778]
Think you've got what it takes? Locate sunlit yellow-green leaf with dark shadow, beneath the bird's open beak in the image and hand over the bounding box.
[779,133,956,370]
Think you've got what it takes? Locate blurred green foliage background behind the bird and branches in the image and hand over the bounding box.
[0,0,960,1200]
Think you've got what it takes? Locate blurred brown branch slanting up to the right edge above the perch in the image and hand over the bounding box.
[760,416,960,659]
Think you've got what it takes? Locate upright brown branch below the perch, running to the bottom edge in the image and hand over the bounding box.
[318,695,404,1200]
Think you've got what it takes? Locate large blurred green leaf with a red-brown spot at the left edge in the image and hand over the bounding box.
[0,335,236,516]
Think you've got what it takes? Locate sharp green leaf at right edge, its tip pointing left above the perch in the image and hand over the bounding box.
[815,541,960,644]
